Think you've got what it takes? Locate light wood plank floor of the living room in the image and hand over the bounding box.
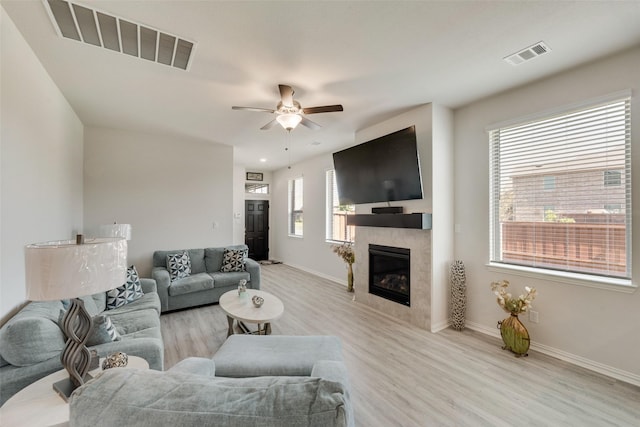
[161,264,640,427]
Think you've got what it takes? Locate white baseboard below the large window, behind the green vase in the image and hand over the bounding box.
[465,321,640,387]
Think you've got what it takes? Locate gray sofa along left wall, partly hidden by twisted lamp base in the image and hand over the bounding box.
[0,279,164,405]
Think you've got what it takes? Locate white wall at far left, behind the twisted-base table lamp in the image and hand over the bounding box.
[0,8,83,323]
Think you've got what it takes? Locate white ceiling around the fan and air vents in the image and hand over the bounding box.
[1,0,640,170]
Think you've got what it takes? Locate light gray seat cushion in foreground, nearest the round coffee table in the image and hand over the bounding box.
[213,335,343,378]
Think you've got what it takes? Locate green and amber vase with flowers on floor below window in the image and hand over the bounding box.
[491,280,537,357]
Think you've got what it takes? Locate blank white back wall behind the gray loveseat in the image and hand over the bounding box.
[84,127,234,277]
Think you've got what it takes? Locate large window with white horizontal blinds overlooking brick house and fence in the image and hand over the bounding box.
[489,97,631,279]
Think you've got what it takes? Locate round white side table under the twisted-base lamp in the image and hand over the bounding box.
[0,356,149,427]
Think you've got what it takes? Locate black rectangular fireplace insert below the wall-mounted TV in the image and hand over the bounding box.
[369,244,411,306]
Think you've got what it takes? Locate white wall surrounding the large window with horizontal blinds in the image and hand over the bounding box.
[454,48,640,384]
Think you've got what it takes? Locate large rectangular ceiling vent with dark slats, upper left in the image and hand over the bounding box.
[44,0,195,70]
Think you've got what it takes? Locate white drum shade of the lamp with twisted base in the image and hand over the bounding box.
[25,238,127,301]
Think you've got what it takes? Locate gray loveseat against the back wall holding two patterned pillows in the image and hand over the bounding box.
[151,245,260,312]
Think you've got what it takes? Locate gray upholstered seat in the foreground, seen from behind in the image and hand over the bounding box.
[69,335,354,427]
